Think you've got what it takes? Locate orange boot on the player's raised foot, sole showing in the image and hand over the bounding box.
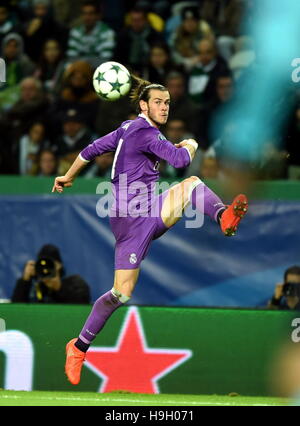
[220,194,248,237]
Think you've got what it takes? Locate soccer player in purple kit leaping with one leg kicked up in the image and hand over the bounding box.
[52,78,248,385]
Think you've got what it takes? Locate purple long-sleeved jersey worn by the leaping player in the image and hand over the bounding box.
[80,114,191,213]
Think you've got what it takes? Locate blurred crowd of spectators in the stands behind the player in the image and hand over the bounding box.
[0,0,300,179]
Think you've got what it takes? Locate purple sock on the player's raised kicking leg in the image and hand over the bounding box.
[190,181,226,222]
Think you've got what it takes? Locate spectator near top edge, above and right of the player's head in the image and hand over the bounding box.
[170,7,213,72]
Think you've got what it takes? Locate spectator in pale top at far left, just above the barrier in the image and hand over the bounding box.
[18,122,49,175]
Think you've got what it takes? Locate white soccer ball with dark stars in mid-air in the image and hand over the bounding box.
[93,61,131,101]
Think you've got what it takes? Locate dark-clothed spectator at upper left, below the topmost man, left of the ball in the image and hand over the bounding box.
[35,39,63,91]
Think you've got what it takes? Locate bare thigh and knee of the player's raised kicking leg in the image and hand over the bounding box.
[160,176,201,228]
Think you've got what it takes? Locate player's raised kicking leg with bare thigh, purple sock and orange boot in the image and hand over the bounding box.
[161,176,248,236]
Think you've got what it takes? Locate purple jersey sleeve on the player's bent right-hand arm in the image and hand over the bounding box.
[140,129,191,168]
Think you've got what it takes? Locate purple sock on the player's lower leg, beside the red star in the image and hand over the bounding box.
[75,290,123,352]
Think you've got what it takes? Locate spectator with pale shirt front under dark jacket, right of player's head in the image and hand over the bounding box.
[188,39,230,107]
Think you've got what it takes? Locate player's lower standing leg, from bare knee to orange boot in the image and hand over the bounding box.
[65,268,139,385]
